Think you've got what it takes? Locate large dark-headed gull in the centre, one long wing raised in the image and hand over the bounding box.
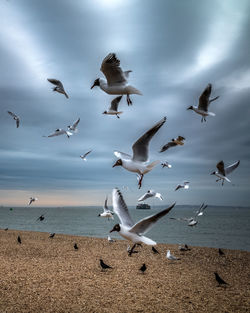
[113,117,167,188]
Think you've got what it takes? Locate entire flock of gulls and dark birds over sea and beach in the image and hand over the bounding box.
[5,53,240,281]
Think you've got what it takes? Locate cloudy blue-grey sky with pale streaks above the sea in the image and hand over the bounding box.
[0,0,250,206]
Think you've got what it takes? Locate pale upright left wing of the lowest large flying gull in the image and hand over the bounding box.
[112,188,134,227]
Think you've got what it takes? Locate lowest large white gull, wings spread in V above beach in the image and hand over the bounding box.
[110,188,175,251]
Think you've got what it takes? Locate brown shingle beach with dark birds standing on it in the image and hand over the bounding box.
[0,230,250,313]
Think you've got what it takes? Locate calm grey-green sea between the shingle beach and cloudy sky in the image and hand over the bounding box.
[0,206,250,251]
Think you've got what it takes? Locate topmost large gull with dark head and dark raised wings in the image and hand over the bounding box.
[91,53,142,105]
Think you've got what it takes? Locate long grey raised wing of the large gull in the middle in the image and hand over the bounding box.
[132,117,167,162]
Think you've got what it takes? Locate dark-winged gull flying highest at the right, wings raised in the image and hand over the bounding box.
[187,84,219,122]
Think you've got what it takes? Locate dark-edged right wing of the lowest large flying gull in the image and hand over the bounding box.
[130,203,175,234]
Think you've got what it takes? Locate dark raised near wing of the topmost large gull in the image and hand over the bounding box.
[101,53,127,85]
